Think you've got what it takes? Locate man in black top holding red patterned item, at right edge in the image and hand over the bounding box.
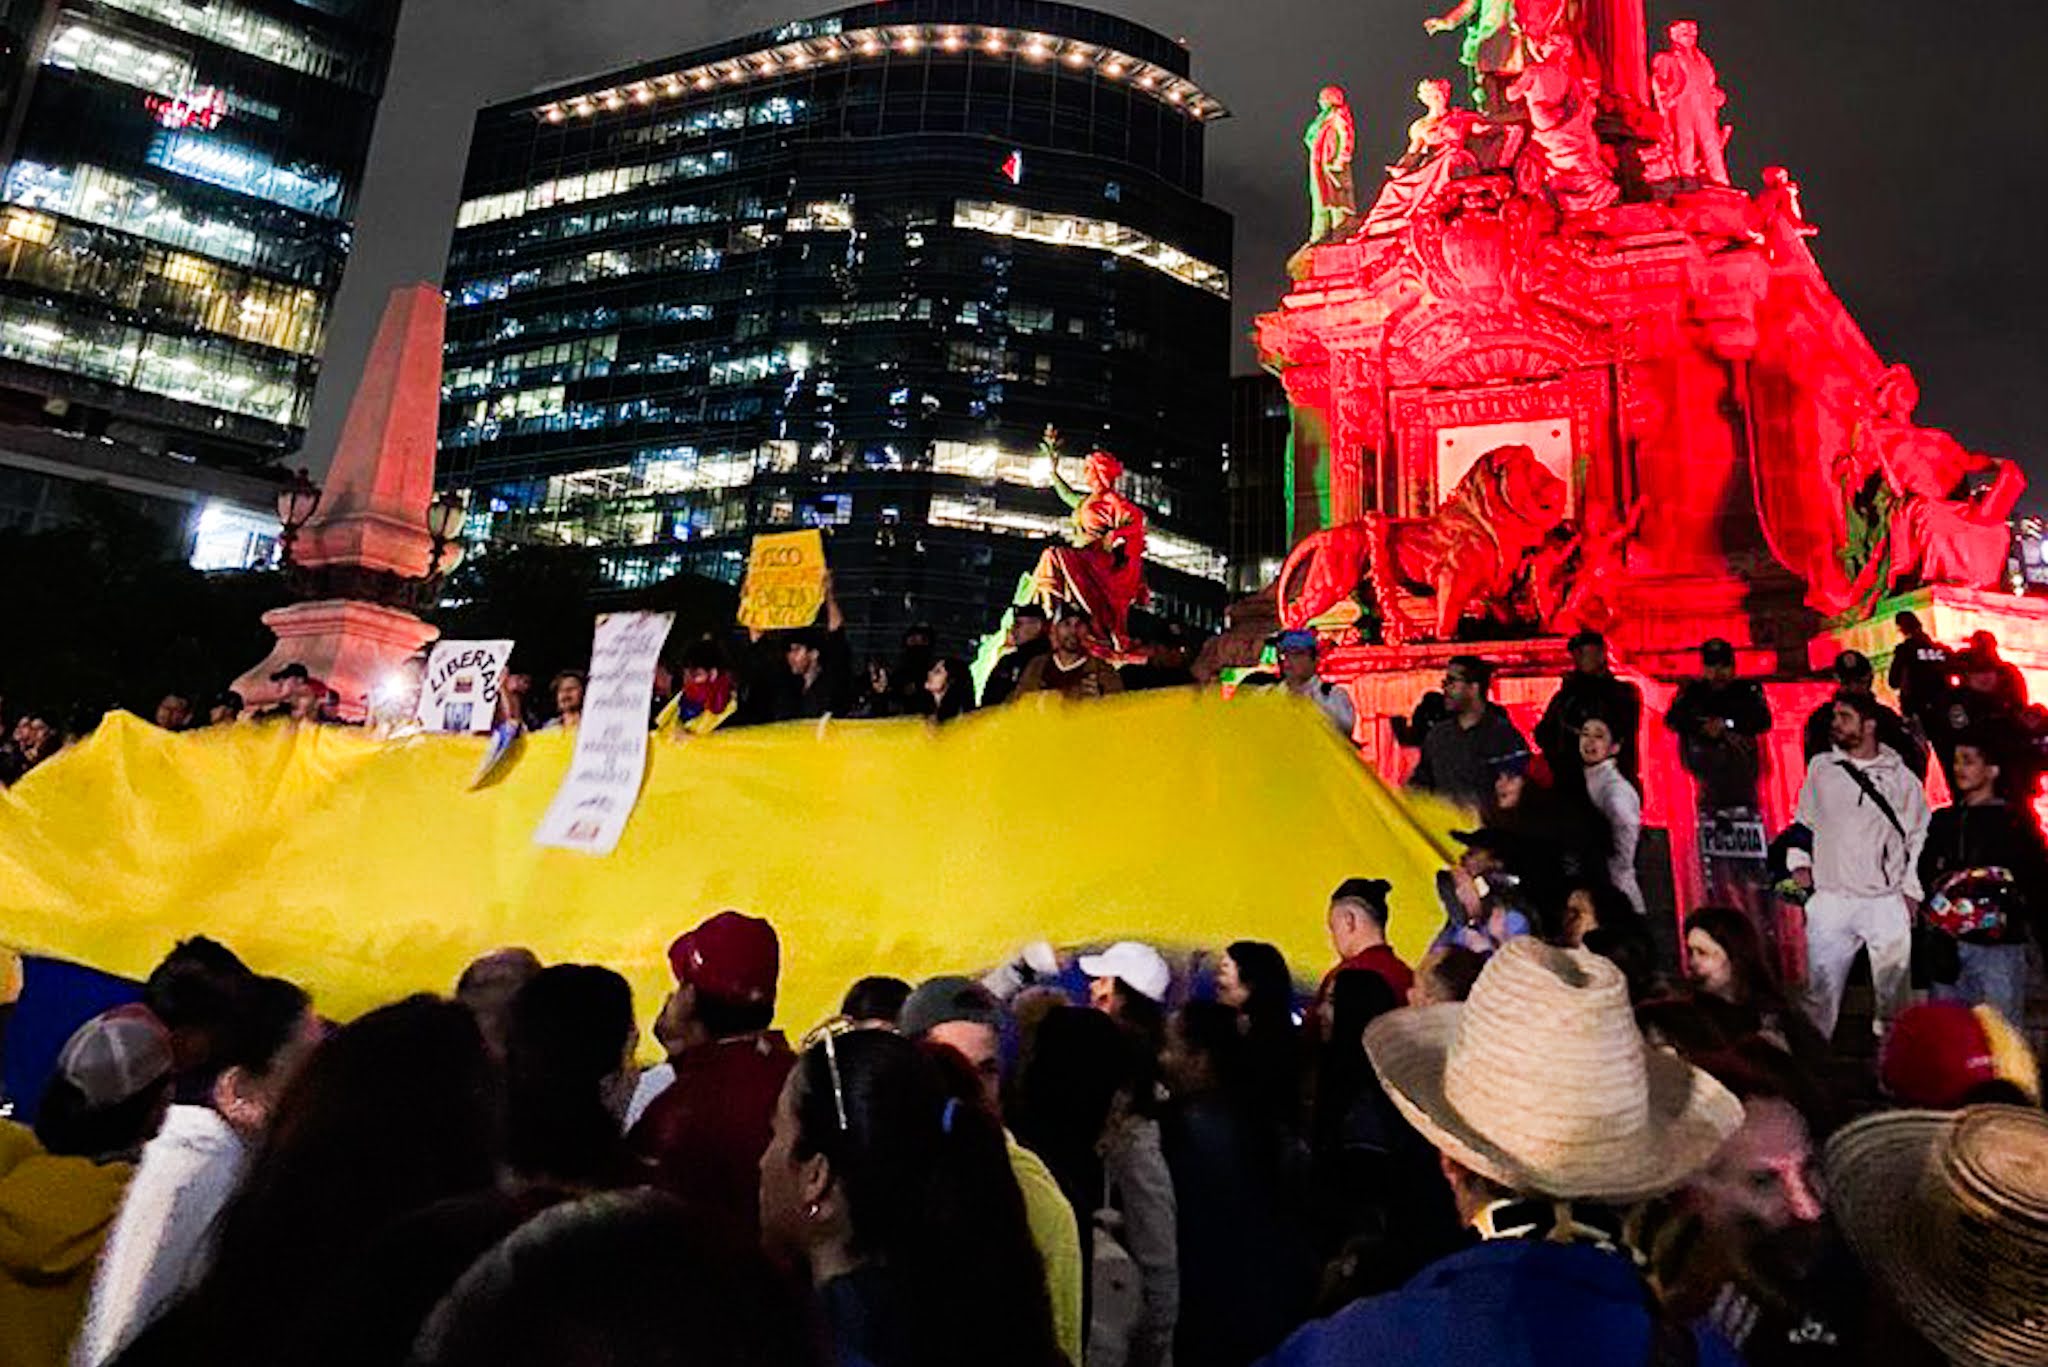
[1919,732,2048,1025]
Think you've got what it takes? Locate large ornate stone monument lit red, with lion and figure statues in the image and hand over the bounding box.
[1253,0,2048,918]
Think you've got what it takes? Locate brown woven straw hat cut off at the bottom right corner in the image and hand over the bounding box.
[1827,1107,2048,1367]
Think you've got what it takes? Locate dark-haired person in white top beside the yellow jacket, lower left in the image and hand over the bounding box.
[72,976,319,1367]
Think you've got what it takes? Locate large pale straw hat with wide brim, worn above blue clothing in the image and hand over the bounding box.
[1366,937,1743,1205]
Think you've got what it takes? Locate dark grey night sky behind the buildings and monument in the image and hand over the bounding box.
[305,0,2048,506]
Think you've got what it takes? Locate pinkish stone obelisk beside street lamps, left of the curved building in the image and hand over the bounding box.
[231,285,459,721]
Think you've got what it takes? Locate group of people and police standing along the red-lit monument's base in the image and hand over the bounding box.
[1409,613,2048,1037]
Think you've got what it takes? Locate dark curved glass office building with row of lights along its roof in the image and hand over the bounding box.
[440,0,1231,652]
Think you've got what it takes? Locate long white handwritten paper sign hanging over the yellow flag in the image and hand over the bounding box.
[532,613,676,855]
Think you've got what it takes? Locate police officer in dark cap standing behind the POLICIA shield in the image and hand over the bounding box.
[1665,637,1776,926]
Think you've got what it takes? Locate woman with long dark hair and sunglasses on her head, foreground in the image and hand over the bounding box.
[758,1021,1065,1367]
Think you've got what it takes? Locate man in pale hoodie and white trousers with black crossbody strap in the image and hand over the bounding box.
[1788,693,1927,1035]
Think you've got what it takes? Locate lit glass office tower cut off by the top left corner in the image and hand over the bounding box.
[0,0,397,465]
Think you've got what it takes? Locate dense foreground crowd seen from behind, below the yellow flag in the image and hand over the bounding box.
[0,864,2048,1367]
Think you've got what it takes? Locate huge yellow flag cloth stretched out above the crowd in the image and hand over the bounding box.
[0,693,1454,1027]
